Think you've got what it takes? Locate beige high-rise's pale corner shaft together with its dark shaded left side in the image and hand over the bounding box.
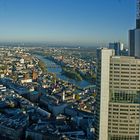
[95,49,115,140]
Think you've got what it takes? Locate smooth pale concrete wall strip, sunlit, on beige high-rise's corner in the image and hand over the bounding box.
[99,49,114,140]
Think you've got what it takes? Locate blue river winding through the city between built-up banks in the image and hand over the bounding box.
[35,55,91,88]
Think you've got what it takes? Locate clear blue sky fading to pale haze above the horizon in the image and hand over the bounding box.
[0,0,136,46]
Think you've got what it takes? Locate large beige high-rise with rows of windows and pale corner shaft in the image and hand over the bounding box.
[95,49,140,140]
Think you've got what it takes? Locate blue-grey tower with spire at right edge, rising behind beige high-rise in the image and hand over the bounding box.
[129,0,140,57]
